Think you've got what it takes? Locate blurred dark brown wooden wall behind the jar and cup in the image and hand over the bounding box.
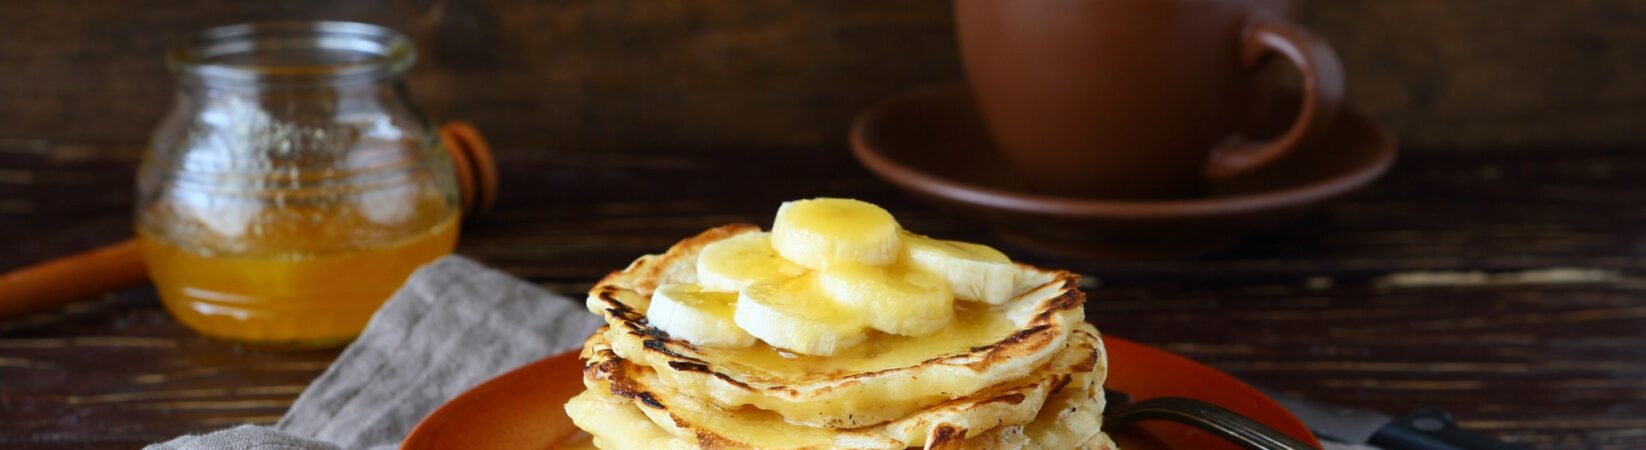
[12,0,1646,267]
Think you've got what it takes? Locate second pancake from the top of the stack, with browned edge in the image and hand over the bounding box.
[584,325,1108,448]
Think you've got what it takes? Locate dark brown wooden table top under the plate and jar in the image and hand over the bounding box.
[0,138,1646,448]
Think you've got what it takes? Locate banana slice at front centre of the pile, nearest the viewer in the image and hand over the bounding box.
[734,275,867,356]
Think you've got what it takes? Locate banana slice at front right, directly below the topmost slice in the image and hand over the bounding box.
[818,264,955,336]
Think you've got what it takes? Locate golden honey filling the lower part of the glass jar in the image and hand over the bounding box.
[137,192,458,346]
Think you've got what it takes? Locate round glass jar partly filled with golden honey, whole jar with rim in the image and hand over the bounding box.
[137,21,461,348]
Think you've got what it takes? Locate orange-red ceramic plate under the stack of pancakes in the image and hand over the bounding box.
[400,336,1320,450]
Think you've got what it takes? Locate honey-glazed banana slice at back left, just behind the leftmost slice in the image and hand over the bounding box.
[698,232,807,292]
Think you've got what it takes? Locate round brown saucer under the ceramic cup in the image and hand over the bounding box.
[851,82,1396,257]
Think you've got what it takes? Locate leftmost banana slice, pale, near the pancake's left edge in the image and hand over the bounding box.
[645,285,754,348]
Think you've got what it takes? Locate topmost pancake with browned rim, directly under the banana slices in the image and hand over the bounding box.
[586,224,1085,429]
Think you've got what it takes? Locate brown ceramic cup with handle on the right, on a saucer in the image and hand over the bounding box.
[955,0,1343,199]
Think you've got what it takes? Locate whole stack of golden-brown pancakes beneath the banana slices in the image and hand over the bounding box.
[566,224,1116,450]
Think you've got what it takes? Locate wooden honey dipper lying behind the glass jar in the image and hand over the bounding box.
[0,120,497,320]
